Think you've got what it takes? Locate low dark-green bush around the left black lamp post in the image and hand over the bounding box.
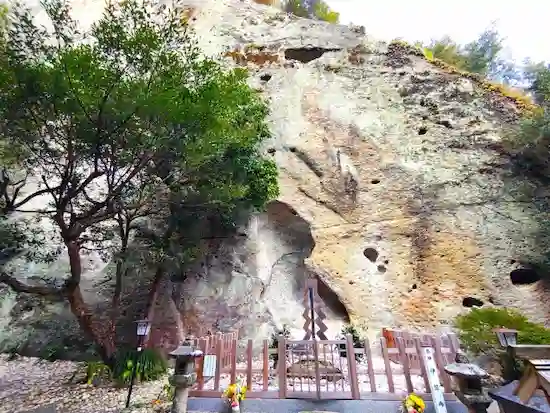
[111,349,168,384]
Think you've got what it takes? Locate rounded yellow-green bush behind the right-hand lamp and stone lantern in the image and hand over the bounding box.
[455,308,550,355]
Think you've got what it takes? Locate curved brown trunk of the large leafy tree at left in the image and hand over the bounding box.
[66,242,116,364]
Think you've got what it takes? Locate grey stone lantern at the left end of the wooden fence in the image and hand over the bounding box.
[170,343,203,413]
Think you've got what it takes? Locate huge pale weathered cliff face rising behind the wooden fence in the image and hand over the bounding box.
[2,0,548,354]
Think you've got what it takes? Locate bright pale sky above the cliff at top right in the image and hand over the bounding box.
[326,0,550,62]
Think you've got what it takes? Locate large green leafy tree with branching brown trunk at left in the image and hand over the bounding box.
[0,0,278,362]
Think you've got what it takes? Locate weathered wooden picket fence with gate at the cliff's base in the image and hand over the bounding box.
[190,331,459,400]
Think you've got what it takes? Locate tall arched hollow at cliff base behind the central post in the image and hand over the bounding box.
[263,201,349,334]
